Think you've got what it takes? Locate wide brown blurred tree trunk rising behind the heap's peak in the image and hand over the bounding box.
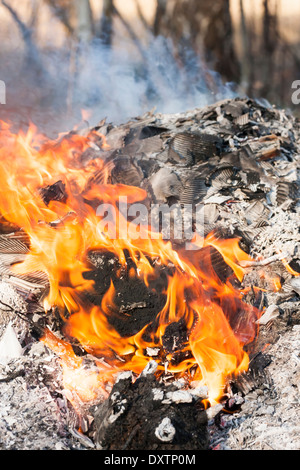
[154,0,240,81]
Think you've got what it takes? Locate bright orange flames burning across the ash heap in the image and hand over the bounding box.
[0,122,258,403]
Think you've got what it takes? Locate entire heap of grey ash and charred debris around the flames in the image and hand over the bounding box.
[0,99,300,450]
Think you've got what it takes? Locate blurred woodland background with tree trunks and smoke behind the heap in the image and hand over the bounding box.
[0,0,300,133]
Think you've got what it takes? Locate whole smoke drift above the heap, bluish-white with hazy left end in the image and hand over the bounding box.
[0,33,239,133]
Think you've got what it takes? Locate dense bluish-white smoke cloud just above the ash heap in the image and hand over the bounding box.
[69,36,238,122]
